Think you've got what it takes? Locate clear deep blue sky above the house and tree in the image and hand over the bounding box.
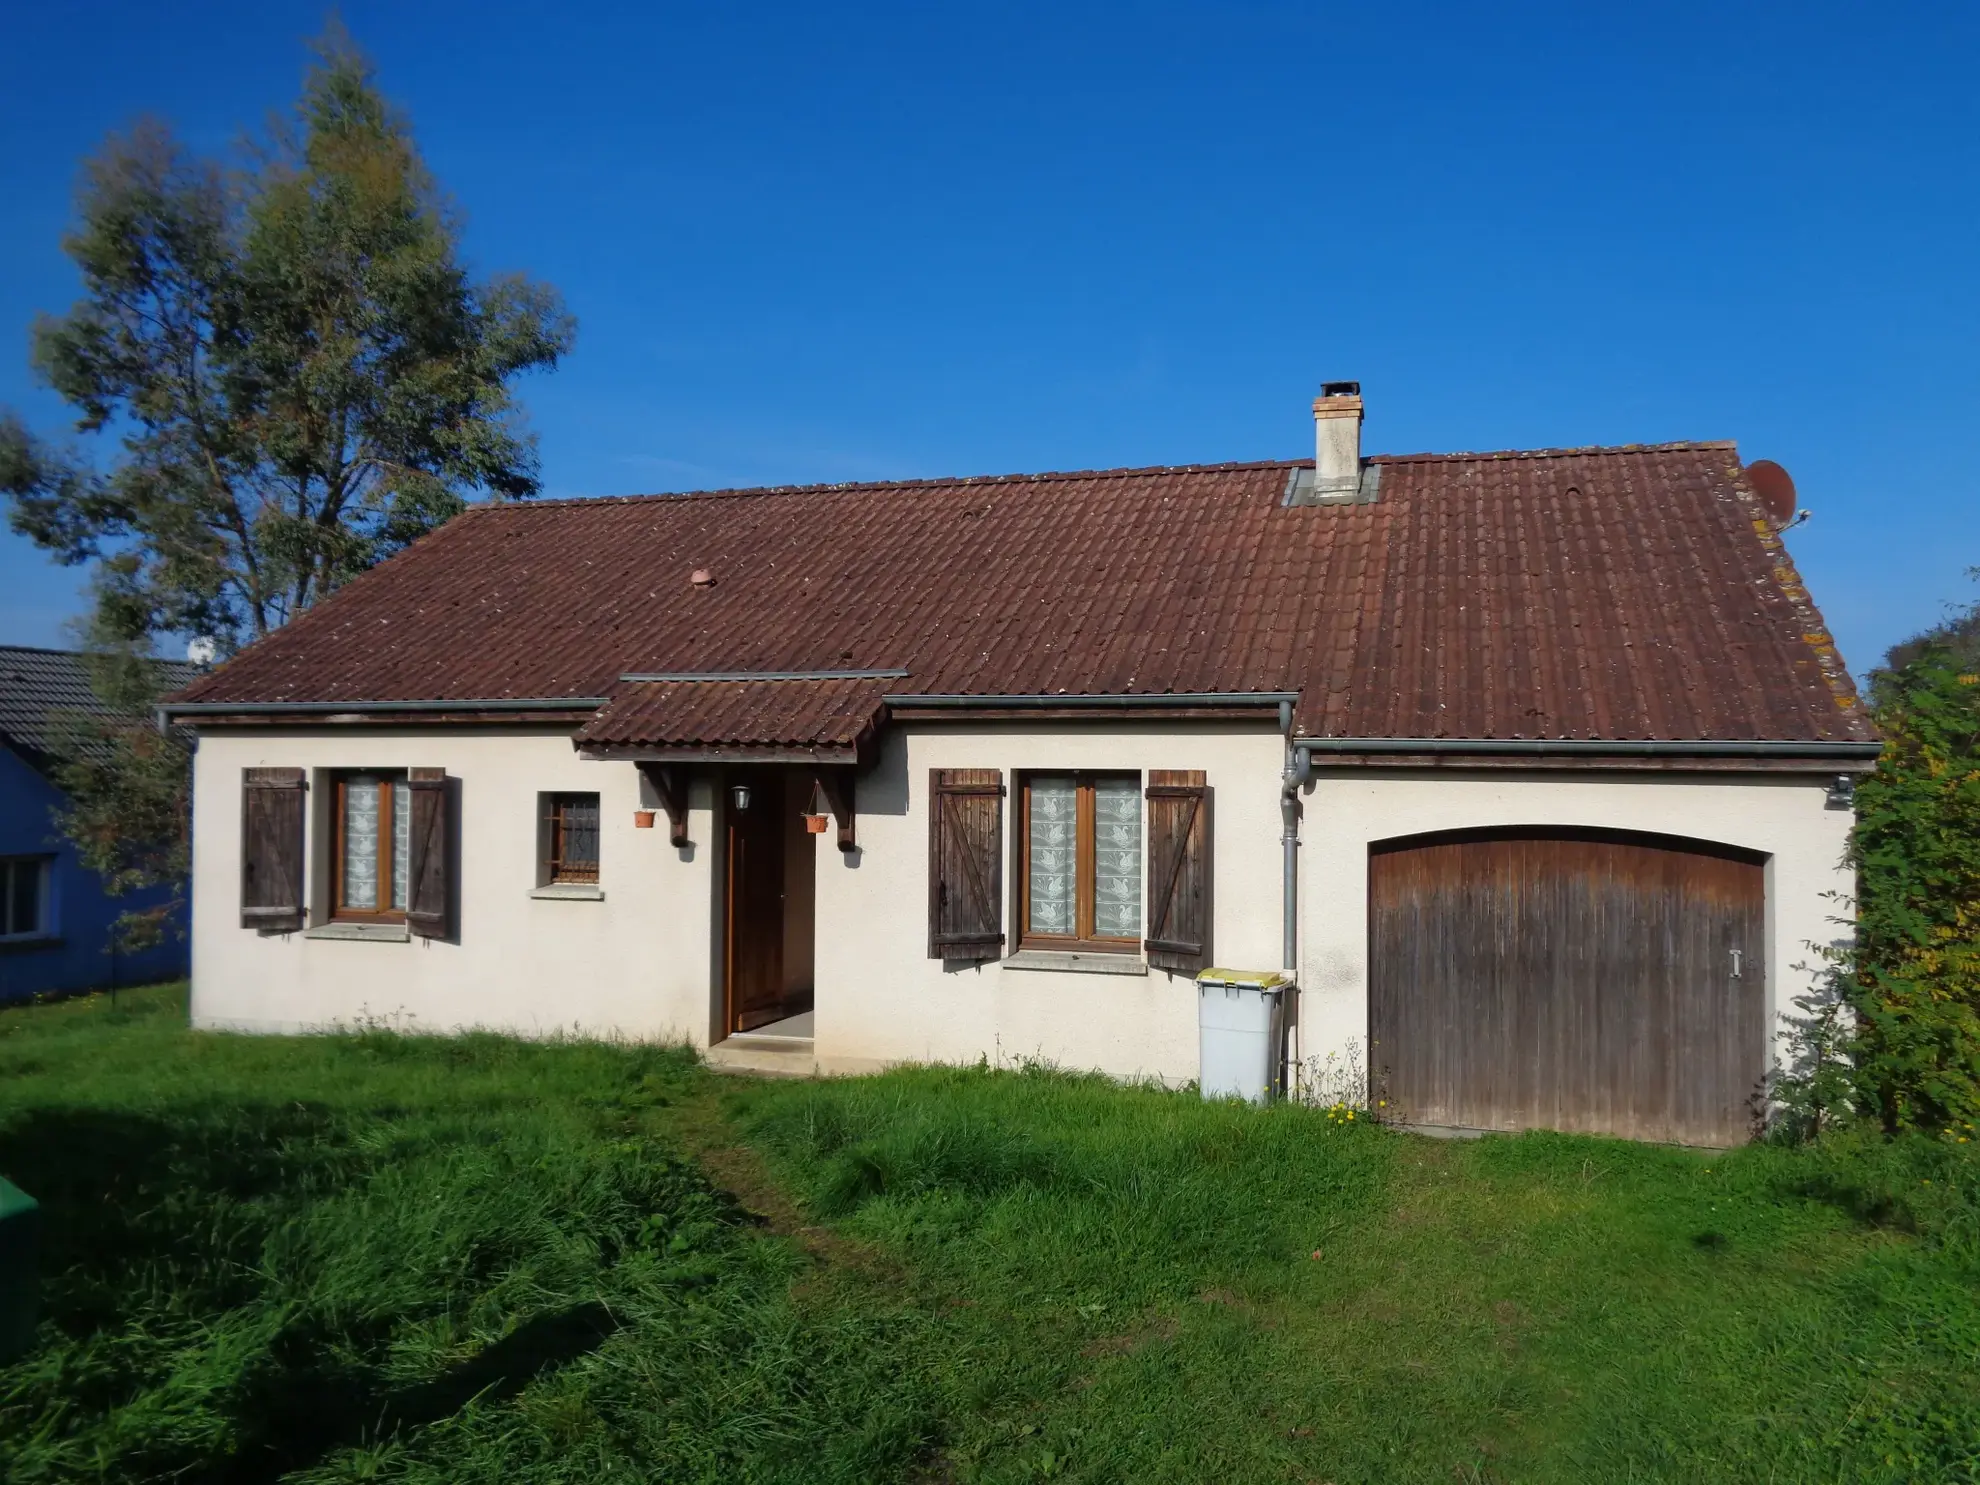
[0,0,1980,671]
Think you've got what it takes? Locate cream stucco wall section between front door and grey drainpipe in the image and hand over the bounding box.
[814,719,1285,1083]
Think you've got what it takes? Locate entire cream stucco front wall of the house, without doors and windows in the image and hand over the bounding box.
[192,723,1849,1108]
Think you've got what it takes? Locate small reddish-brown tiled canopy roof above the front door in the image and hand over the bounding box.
[578,679,901,760]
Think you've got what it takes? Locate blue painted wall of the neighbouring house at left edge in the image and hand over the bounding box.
[0,746,186,1002]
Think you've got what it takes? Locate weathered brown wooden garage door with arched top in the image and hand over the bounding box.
[1368,832,1766,1144]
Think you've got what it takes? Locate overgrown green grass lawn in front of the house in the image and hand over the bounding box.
[0,990,1980,1485]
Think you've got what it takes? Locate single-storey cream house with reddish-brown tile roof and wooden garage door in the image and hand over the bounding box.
[168,382,1877,1142]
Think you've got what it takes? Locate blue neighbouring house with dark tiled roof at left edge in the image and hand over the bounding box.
[0,645,200,1002]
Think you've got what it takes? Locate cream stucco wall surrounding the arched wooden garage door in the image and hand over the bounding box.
[1295,766,1855,1079]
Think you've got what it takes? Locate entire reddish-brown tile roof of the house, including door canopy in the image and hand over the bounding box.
[170,444,1873,741]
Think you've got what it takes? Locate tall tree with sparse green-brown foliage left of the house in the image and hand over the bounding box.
[0,28,574,941]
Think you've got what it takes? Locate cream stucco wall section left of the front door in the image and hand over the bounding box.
[192,727,715,1045]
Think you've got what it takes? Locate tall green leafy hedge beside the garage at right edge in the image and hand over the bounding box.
[1843,644,1980,1133]
